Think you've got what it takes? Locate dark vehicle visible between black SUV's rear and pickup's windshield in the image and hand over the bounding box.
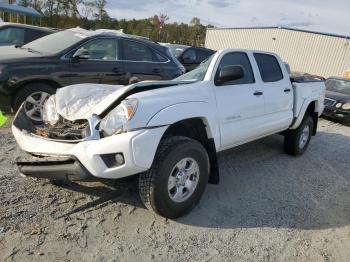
[163,44,215,72]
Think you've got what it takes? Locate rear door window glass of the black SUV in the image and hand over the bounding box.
[124,40,153,62]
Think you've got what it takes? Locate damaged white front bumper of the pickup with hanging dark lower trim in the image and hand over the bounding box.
[12,106,167,180]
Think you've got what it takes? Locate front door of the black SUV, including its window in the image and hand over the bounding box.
[70,37,125,84]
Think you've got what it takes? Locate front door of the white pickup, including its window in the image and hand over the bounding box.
[215,52,265,149]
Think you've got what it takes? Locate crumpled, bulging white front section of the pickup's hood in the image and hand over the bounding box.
[55,84,126,121]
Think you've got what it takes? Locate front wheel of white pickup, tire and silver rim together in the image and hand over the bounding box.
[139,136,209,218]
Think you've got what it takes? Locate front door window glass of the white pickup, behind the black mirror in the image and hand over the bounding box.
[216,52,255,85]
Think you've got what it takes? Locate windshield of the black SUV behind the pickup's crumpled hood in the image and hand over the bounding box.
[22,30,86,54]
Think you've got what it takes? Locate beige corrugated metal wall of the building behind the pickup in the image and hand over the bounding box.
[205,28,350,77]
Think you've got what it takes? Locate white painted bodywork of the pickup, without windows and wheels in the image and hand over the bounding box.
[12,49,325,178]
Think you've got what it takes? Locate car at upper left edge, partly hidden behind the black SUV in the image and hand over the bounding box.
[0,22,56,46]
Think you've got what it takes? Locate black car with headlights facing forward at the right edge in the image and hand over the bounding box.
[323,77,350,124]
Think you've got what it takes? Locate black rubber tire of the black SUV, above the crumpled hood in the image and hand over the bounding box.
[13,83,56,111]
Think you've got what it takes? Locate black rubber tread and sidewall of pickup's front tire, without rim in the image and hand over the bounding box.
[139,136,210,219]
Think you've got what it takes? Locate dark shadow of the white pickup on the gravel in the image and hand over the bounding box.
[56,132,350,229]
